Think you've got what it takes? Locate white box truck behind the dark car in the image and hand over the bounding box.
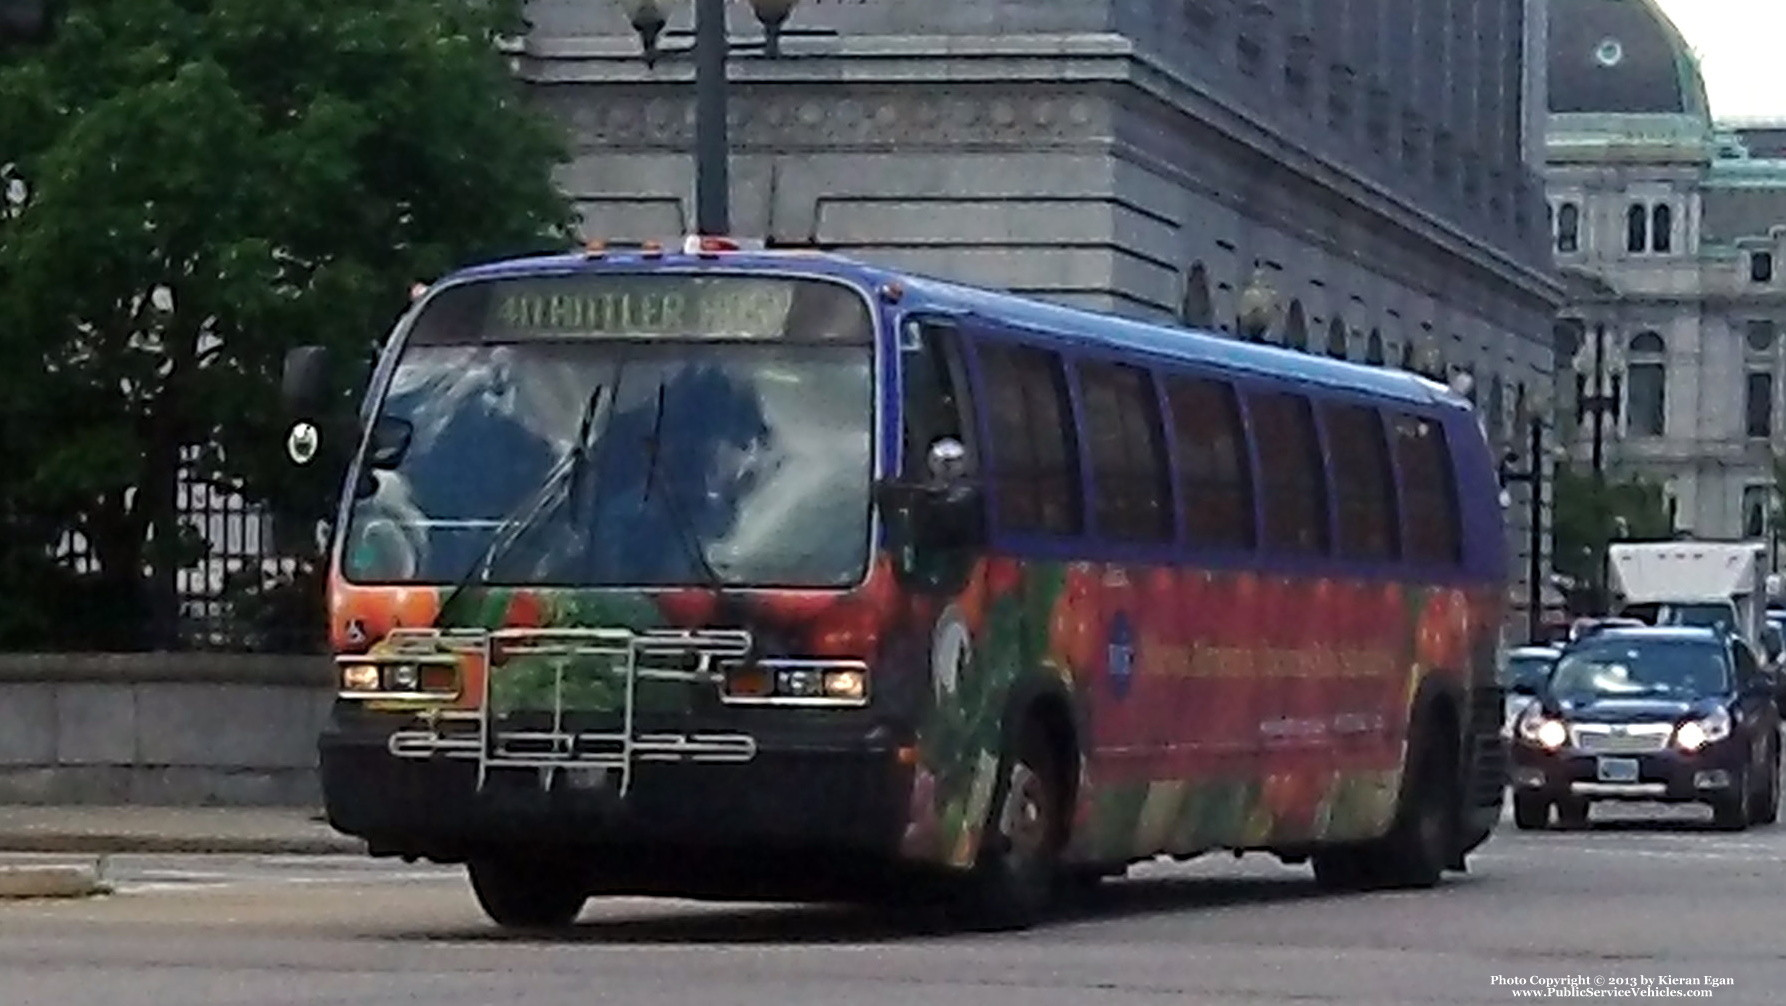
[1609,541,1768,652]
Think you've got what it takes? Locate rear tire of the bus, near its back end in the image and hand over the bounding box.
[1365,709,1457,888]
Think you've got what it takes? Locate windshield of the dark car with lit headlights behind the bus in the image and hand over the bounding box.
[1550,640,1729,700]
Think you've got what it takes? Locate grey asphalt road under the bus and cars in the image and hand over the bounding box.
[0,804,1786,1006]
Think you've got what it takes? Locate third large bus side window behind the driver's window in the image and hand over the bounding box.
[1166,377,1259,549]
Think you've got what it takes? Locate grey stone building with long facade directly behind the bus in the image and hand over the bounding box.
[516,0,1561,625]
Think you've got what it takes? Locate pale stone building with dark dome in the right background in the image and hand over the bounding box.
[1547,0,1786,557]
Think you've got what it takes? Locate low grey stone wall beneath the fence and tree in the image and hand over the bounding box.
[0,654,332,806]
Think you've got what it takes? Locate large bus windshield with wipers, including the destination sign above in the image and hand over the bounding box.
[343,273,873,586]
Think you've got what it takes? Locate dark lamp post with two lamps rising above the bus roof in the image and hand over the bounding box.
[616,0,800,238]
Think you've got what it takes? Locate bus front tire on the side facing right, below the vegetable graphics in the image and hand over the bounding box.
[959,718,1066,931]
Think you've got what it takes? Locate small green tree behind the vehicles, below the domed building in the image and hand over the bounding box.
[1550,465,1675,596]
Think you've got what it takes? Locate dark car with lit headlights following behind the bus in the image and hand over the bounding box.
[1513,627,1781,829]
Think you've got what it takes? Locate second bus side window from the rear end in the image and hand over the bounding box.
[1322,406,1400,559]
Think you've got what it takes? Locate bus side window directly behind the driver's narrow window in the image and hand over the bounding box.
[977,341,1084,534]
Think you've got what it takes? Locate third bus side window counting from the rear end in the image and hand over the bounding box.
[1247,391,1329,554]
